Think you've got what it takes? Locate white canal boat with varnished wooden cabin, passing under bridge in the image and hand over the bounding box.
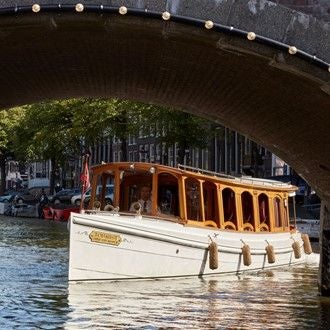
[69,162,315,281]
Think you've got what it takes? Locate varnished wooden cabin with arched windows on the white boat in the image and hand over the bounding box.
[88,163,297,232]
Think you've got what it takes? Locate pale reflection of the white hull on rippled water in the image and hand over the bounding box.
[67,267,329,329]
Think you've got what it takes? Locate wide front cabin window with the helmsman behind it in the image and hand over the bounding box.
[119,170,152,213]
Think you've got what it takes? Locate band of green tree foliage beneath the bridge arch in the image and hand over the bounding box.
[5,99,217,164]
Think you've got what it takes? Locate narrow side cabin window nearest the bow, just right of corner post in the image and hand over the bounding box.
[185,178,203,221]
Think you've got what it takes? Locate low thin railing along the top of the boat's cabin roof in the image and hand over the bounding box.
[177,164,291,187]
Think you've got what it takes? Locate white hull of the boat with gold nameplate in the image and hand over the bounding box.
[69,213,315,281]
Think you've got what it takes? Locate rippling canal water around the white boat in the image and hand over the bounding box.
[0,217,330,329]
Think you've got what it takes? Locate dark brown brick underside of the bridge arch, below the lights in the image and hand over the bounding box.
[0,3,330,202]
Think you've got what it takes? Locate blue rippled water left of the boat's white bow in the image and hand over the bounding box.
[0,217,69,329]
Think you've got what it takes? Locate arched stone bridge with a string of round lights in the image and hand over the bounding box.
[0,0,330,294]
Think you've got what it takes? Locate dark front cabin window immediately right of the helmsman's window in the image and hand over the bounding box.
[158,173,179,216]
